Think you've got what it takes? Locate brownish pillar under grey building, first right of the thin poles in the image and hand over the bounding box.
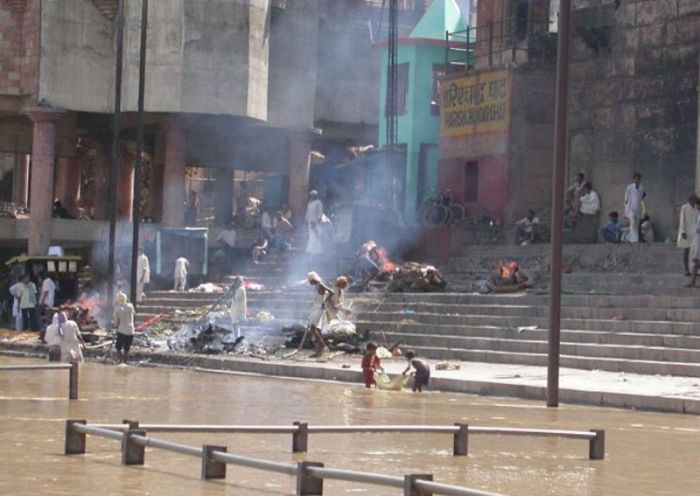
[162,119,187,227]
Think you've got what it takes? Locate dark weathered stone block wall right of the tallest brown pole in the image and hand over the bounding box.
[569,0,700,238]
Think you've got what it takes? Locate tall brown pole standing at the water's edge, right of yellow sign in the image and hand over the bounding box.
[547,0,571,407]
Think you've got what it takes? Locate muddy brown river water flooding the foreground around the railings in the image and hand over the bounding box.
[0,357,700,496]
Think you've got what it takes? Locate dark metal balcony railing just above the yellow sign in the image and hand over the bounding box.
[445,17,556,70]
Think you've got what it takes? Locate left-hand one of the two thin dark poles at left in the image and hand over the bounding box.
[107,0,124,314]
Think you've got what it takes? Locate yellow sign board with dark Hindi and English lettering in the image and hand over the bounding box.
[440,70,511,136]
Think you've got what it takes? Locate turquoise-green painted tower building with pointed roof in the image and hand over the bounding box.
[378,0,467,222]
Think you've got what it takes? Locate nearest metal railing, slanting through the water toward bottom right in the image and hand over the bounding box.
[64,420,508,496]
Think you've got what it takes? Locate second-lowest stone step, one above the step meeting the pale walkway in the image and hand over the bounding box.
[375,333,700,364]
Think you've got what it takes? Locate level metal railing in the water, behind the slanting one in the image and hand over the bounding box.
[87,422,605,460]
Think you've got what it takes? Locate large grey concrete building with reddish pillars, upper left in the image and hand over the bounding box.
[0,0,432,260]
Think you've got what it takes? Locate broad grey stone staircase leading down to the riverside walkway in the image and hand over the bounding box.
[139,244,700,377]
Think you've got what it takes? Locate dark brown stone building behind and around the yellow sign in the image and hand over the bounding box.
[440,0,700,239]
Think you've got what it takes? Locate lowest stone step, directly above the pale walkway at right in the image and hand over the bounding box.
[400,346,700,377]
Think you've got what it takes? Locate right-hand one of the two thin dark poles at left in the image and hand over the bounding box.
[130,0,148,305]
